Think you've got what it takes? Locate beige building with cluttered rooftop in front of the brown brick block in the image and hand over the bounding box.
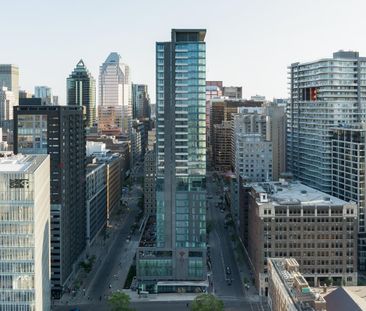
[268,258,328,311]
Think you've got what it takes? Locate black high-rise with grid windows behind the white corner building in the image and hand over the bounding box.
[14,105,86,297]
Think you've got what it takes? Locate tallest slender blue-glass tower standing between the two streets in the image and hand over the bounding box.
[137,29,207,291]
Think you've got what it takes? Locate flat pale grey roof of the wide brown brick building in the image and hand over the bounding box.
[249,180,347,206]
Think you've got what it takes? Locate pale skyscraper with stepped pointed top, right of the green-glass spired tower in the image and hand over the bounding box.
[98,52,132,134]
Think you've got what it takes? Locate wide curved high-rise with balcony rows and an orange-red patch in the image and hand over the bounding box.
[286,51,366,269]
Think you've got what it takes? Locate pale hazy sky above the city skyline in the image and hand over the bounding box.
[0,0,366,103]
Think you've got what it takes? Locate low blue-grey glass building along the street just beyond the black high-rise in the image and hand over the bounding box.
[86,161,107,247]
